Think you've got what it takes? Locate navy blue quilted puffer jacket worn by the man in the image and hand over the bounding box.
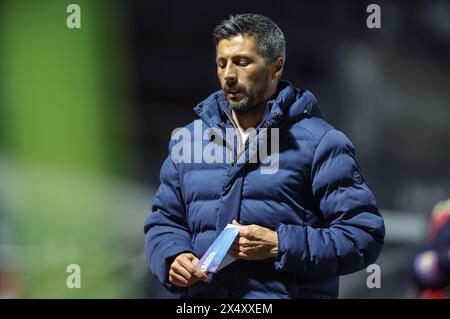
[145,81,384,298]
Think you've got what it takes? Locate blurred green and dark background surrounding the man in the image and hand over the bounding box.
[0,0,450,298]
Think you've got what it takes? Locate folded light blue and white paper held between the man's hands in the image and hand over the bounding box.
[197,224,241,273]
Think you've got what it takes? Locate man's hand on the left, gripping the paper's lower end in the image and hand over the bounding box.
[169,253,208,287]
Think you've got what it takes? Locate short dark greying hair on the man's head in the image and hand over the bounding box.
[213,13,286,62]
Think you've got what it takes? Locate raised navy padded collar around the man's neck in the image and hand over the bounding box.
[194,80,322,127]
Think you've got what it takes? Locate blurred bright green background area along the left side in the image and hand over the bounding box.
[0,0,148,298]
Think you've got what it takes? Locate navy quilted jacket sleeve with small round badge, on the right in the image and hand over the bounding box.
[275,129,385,282]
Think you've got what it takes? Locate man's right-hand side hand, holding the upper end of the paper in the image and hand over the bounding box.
[229,220,278,260]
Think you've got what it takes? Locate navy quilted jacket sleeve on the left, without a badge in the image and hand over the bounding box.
[144,142,193,293]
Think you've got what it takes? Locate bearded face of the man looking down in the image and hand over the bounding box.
[216,35,273,113]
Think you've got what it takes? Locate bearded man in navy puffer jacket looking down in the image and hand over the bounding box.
[144,14,384,298]
